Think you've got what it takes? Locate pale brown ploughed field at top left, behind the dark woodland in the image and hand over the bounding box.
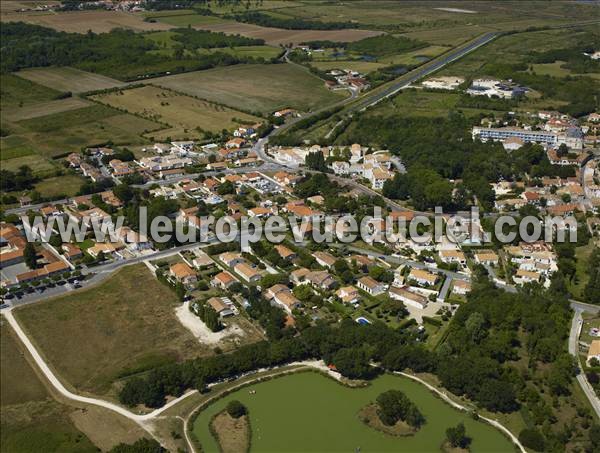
[0,10,171,33]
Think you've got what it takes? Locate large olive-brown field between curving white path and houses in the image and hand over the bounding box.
[15,264,203,393]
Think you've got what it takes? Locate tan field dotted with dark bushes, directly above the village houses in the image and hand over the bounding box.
[91,85,260,137]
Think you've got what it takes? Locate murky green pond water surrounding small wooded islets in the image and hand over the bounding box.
[194,372,515,453]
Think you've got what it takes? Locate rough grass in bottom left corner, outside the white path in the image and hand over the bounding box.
[0,320,97,453]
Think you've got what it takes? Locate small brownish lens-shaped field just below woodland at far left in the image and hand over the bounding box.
[17,67,125,93]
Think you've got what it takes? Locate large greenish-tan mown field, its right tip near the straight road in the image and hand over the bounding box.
[152,64,344,113]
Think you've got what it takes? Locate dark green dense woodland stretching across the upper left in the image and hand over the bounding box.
[0,22,272,81]
